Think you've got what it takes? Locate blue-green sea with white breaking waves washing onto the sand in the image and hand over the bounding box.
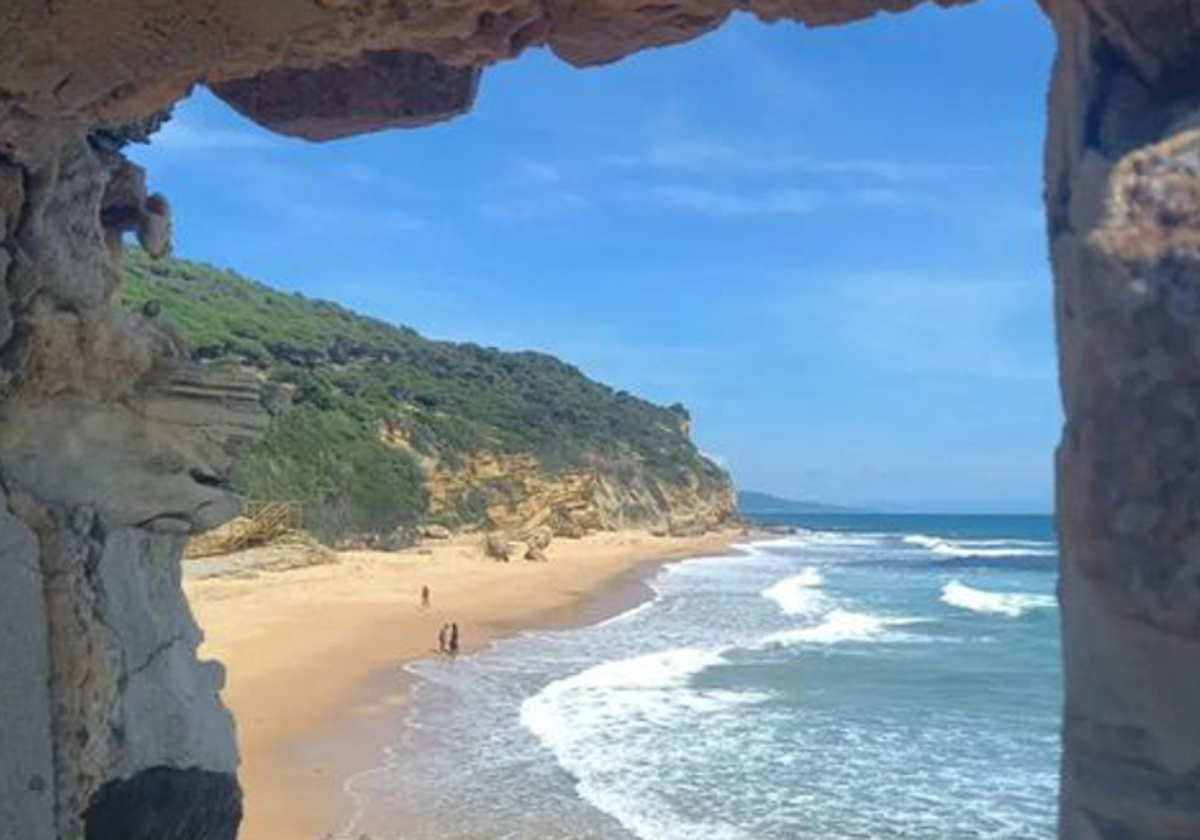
[348,515,1062,840]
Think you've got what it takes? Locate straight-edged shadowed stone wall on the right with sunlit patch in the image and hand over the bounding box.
[1046,0,1200,840]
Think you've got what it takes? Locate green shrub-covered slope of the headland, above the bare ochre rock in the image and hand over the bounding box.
[125,252,725,538]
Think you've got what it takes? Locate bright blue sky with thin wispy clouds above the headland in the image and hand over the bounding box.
[134,0,1061,510]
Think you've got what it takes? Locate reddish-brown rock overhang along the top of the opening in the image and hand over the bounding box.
[0,0,968,151]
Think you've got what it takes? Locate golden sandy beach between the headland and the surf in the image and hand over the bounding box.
[185,532,742,840]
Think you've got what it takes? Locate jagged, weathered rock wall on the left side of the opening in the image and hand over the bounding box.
[0,128,266,840]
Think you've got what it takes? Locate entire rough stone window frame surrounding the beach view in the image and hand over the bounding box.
[0,0,1200,840]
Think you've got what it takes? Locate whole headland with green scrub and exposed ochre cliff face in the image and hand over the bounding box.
[124,252,736,540]
